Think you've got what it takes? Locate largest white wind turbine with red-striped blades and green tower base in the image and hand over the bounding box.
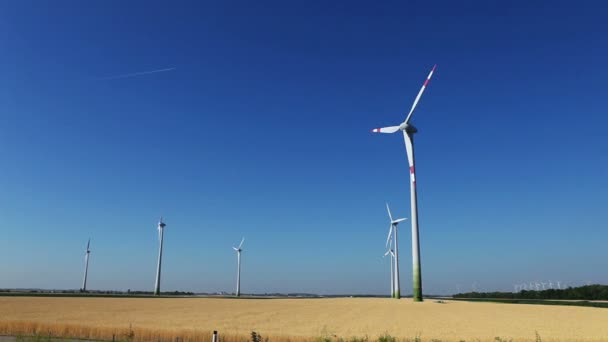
[372,65,437,302]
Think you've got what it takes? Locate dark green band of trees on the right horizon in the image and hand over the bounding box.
[453,285,608,300]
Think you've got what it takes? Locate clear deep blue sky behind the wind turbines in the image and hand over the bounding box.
[0,1,608,294]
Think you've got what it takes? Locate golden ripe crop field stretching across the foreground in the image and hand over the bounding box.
[0,297,608,342]
